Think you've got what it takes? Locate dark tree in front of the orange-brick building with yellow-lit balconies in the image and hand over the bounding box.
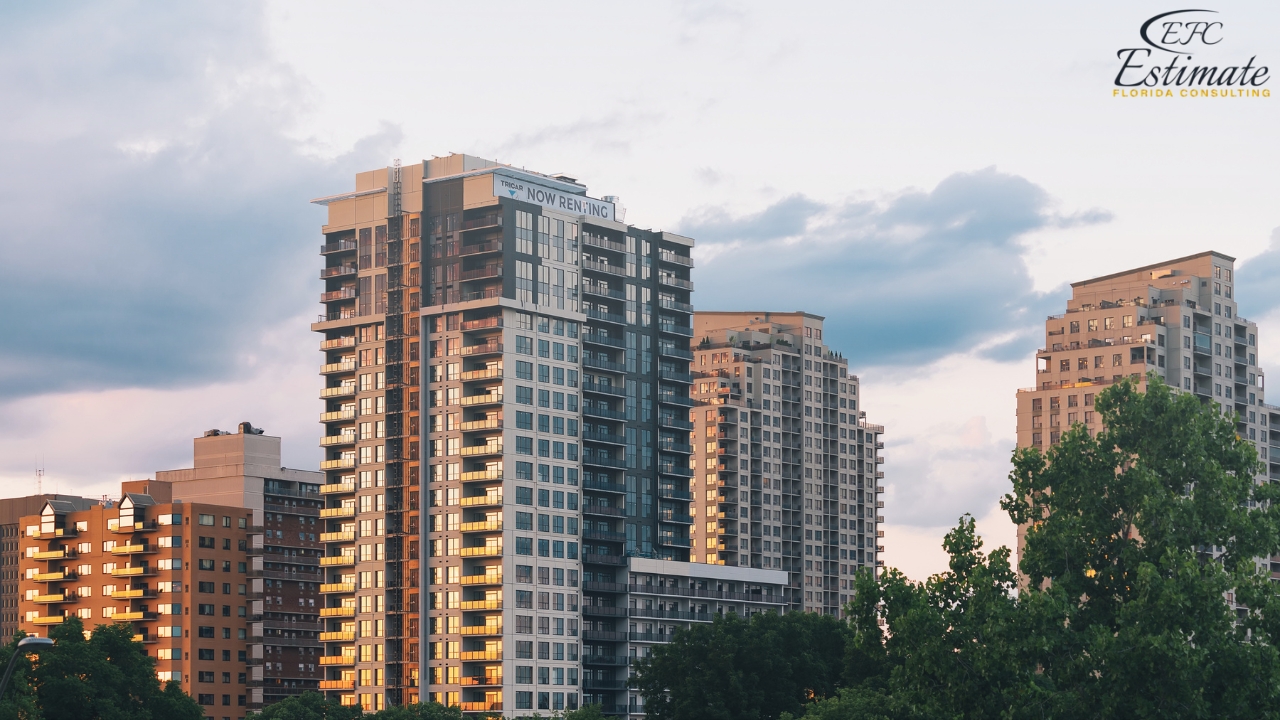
[31,616,205,720]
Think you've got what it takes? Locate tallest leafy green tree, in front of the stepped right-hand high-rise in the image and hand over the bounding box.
[1002,375,1280,717]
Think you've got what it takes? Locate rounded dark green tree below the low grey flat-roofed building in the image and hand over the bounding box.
[634,604,849,720]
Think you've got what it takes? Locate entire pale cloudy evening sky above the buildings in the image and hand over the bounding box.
[0,0,1280,579]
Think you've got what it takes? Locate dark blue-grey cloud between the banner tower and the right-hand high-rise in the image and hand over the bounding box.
[680,168,1110,365]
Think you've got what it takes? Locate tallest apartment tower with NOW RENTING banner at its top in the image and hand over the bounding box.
[314,155,694,715]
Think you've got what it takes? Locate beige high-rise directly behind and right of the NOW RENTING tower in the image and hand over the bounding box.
[691,311,884,615]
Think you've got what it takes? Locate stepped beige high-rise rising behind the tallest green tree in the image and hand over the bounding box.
[1018,252,1280,570]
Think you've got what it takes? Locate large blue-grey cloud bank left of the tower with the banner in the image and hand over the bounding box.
[0,3,396,400]
